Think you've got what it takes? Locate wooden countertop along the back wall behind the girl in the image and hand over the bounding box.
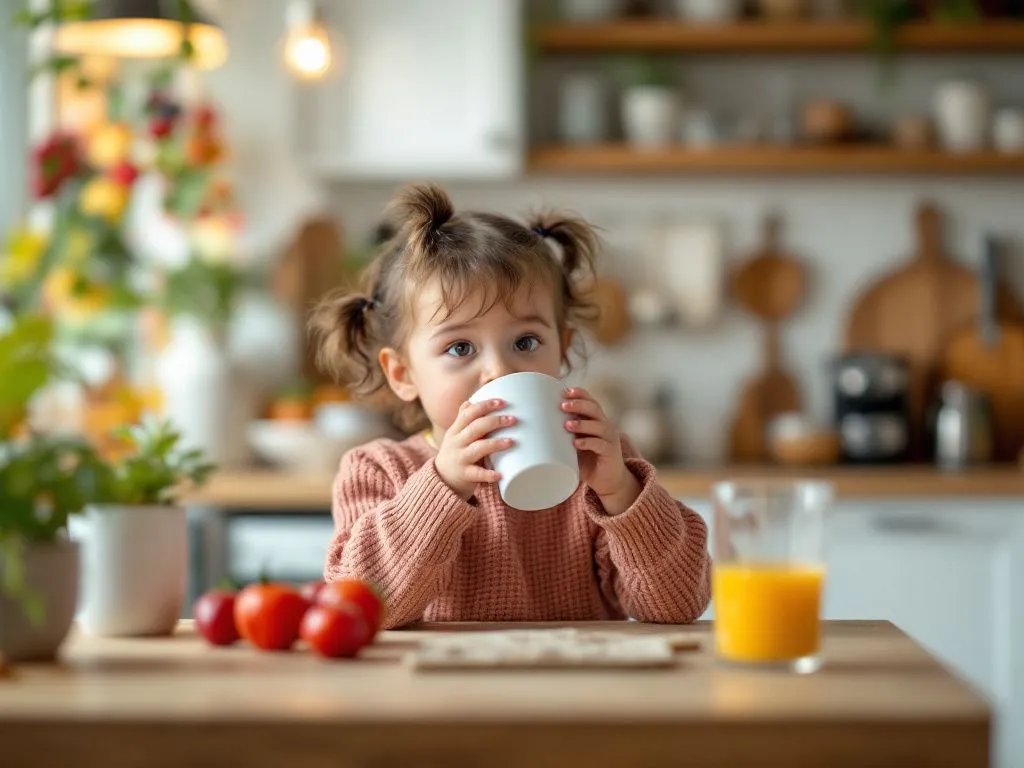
[186,465,1024,511]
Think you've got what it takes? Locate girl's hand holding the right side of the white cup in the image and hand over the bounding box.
[562,387,640,515]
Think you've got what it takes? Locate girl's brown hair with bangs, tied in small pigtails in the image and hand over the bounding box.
[309,183,598,431]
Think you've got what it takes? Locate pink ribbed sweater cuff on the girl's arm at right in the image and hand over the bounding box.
[586,459,705,570]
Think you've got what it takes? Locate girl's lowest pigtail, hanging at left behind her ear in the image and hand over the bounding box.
[309,291,380,392]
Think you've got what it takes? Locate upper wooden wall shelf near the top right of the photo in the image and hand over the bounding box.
[538,19,1024,53]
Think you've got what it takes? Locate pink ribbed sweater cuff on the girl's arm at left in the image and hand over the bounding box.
[394,461,477,563]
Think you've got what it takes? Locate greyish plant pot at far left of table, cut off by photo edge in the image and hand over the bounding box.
[0,538,79,663]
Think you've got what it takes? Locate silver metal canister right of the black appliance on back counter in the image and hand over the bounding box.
[935,381,992,469]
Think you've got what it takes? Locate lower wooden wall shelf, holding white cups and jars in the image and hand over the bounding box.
[527,144,1024,175]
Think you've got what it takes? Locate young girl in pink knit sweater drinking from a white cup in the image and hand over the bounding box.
[312,184,711,627]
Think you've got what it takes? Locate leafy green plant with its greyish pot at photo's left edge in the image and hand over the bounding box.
[0,314,103,662]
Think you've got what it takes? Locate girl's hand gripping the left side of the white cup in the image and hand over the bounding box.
[434,400,515,501]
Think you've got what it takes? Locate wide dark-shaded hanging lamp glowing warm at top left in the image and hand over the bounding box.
[54,0,227,70]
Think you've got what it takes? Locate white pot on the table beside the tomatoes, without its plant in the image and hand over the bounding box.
[71,505,188,637]
